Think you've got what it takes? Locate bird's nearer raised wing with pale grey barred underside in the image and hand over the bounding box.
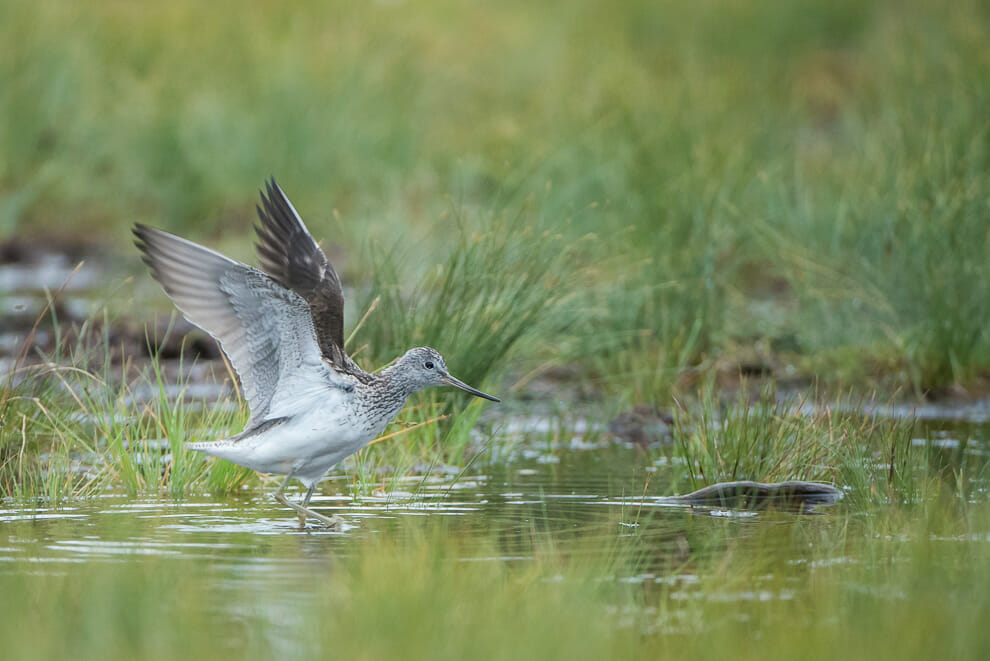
[134,224,353,428]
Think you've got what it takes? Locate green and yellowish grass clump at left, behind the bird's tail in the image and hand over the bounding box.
[0,320,244,504]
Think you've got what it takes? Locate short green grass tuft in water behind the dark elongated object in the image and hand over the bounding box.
[663,388,936,507]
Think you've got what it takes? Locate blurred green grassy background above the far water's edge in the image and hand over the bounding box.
[0,0,990,399]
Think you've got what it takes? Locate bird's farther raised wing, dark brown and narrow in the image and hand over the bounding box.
[254,178,353,371]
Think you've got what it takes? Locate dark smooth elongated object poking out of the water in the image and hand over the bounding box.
[673,481,842,512]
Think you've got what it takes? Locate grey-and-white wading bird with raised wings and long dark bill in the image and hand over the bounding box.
[132,177,500,528]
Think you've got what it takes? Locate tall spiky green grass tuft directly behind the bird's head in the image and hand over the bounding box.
[356,206,578,394]
